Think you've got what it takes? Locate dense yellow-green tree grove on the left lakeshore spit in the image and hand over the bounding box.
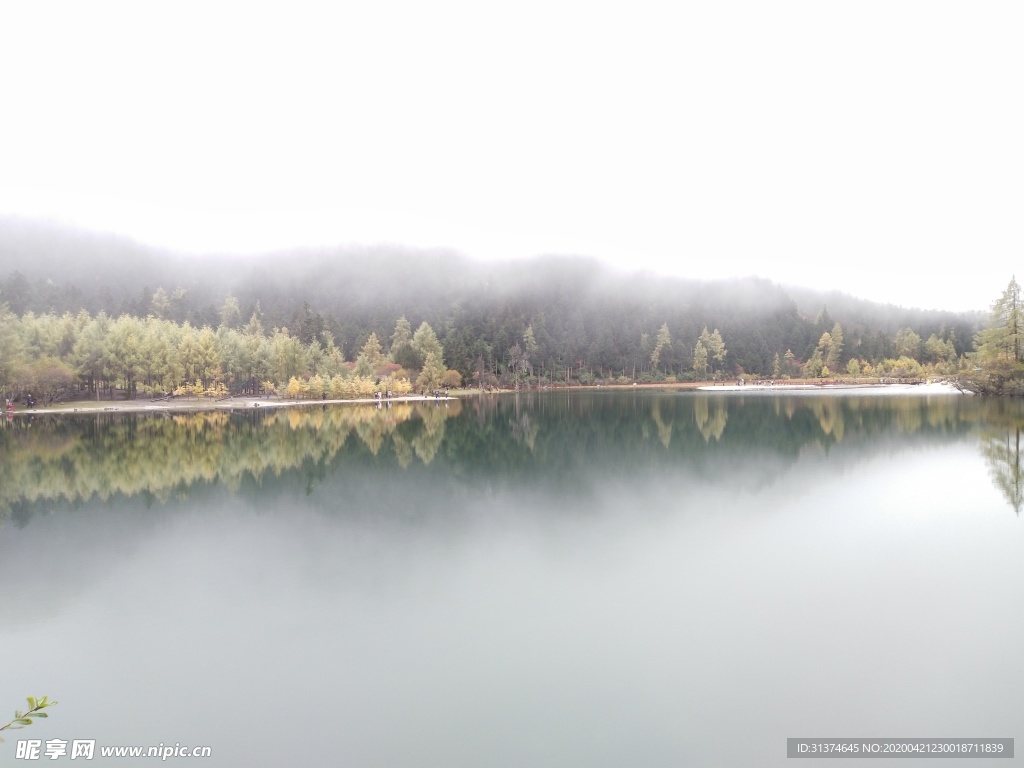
[0,305,462,402]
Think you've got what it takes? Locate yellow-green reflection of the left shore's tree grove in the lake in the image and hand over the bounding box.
[0,402,460,513]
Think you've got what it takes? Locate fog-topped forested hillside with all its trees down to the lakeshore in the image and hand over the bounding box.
[0,214,984,401]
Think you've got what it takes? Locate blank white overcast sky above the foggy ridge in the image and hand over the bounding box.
[0,0,1024,309]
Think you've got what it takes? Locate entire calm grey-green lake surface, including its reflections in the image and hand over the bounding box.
[0,391,1024,767]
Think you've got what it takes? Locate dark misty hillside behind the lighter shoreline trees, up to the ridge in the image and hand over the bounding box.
[0,219,983,375]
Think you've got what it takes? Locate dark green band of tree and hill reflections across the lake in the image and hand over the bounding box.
[0,392,1024,519]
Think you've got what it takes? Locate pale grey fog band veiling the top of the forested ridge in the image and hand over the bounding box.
[0,217,983,332]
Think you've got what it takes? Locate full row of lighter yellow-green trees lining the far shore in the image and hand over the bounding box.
[0,289,988,402]
